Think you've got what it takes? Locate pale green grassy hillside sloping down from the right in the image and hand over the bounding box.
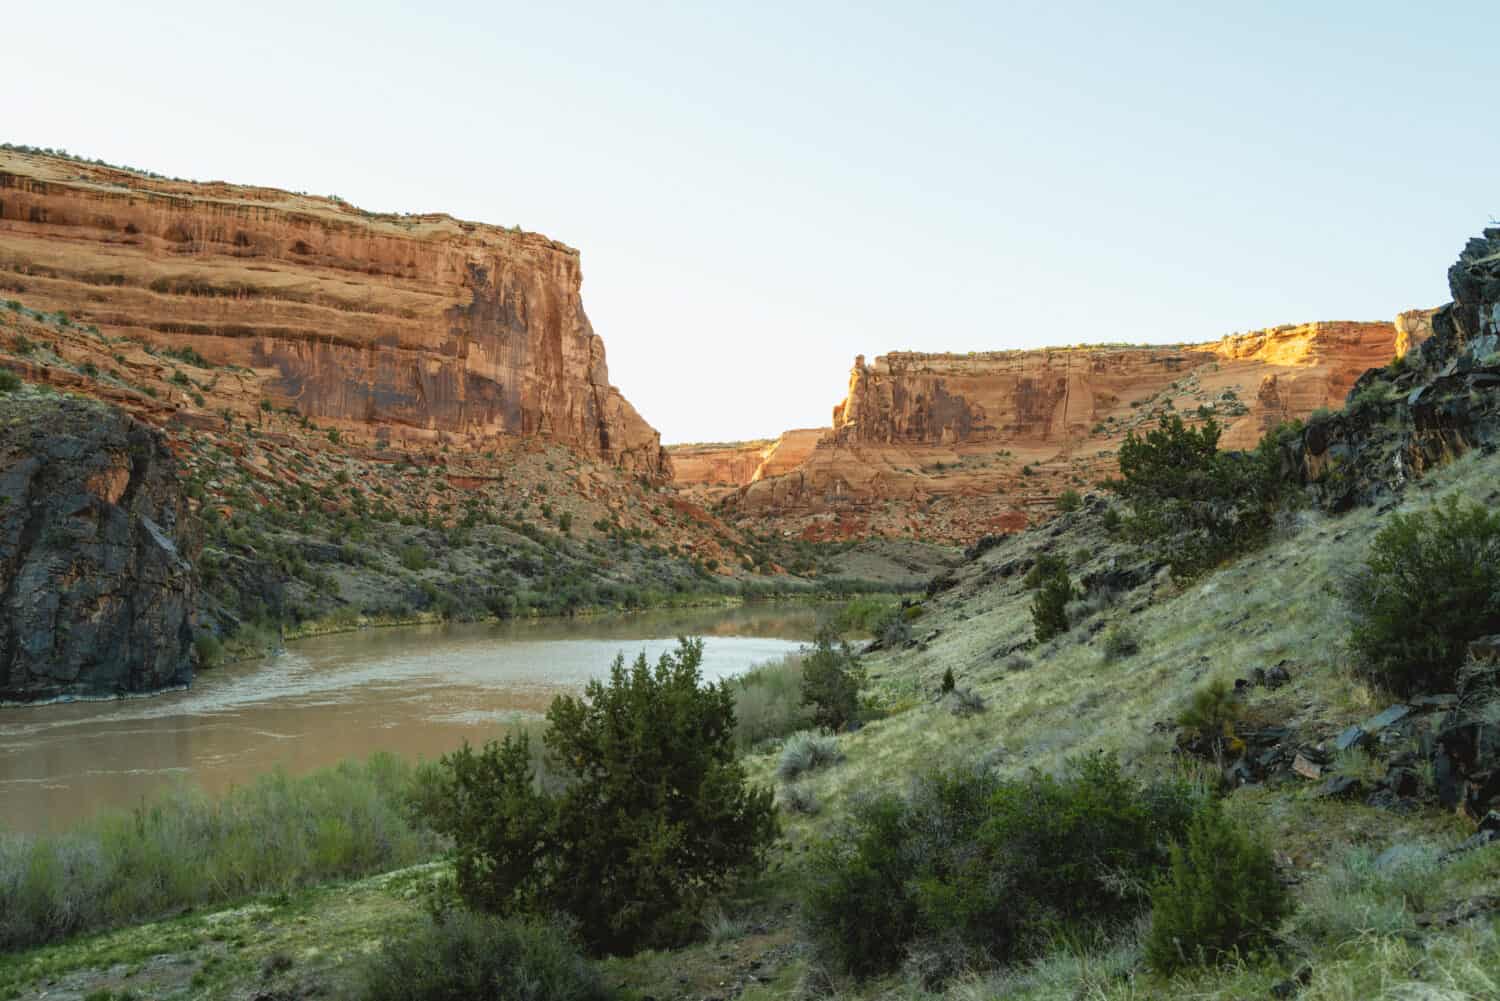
[0,453,1500,1001]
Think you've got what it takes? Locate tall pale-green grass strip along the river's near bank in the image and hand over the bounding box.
[0,755,438,948]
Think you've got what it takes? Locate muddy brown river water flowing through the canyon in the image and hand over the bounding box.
[0,605,818,831]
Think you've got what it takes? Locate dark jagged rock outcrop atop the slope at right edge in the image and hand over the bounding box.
[1284,228,1500,512]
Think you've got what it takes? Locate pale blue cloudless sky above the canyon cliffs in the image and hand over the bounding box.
[0,0,1500,443]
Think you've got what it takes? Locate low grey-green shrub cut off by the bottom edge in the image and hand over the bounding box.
[357,911,615,1001]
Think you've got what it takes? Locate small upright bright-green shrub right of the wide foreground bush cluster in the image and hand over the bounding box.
[1146,803,1292,972]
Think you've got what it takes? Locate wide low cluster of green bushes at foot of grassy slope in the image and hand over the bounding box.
[803,755,1194,980]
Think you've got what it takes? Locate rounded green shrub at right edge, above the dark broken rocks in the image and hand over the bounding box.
[1346,498,1500,696]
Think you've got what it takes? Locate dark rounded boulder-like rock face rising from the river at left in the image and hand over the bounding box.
[0,393,198,702]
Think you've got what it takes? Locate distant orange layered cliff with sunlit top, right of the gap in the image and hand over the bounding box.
[696,319,1410,542]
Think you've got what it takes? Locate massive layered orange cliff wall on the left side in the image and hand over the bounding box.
[0,150,671,480]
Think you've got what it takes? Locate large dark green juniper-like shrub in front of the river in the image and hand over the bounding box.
[428,639,777,953]
